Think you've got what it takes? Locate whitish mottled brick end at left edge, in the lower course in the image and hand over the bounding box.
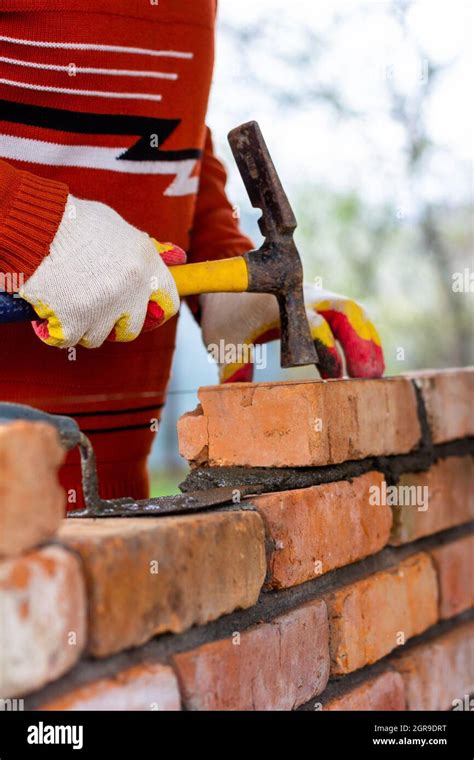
[0,546,86,698]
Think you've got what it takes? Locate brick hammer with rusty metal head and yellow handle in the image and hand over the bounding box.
[0,121,318,368]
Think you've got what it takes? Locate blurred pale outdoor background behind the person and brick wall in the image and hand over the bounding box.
[150,0,474,495]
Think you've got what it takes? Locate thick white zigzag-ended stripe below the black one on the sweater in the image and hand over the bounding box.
[0,135,198,196]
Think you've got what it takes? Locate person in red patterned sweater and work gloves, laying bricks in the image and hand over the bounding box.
[0,0,383,508]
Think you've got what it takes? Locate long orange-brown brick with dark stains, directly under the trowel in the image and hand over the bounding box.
[59,511,266,657]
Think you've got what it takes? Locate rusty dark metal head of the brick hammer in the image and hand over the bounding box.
[228,121,318,367]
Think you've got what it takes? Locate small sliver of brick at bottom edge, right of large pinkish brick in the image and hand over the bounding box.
[321,670,406,711]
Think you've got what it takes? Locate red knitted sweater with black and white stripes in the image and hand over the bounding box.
[0,0,251,507]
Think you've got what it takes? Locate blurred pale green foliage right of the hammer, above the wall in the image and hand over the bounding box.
[295,186,474,374]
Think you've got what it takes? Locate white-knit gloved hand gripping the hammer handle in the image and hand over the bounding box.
[19,195,186,348]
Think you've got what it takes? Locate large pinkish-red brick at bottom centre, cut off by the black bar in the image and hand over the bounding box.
[172,600,329,710]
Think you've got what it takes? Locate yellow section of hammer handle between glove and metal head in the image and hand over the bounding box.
[169,256,249,296]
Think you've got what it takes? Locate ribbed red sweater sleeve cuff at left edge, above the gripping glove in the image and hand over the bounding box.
[0,161,68,279]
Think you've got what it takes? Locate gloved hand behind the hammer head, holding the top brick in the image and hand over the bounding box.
[201,285,384,383]
